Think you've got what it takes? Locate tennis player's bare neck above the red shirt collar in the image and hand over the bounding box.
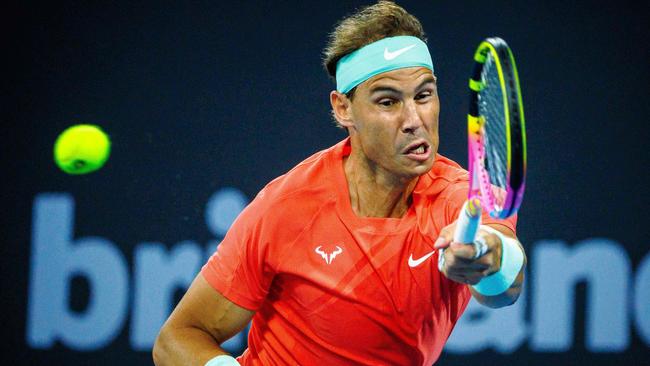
[343,147,417,218]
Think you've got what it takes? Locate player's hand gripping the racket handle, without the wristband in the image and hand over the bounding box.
[434,222,501,285]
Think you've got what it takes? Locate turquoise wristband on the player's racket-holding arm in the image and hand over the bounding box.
[472,225,524,296]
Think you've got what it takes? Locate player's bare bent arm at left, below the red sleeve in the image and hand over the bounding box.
[153,274,254,365]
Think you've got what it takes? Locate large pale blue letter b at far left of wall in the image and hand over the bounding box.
[27,194,128,350]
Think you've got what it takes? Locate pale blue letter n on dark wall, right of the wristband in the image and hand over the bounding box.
[531,239,631,352]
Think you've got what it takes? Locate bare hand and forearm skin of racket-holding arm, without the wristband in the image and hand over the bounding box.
[436,223,526,308]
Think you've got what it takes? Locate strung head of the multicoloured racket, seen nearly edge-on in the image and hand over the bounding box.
[467,37,526,219]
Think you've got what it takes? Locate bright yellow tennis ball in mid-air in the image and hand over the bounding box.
[54,124,111,174]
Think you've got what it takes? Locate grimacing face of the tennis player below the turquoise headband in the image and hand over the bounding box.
[351,67,440,178]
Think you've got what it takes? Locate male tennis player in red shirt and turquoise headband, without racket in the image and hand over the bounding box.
[153,1,524,366]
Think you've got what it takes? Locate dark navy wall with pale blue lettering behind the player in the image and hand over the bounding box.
[5,1,650,365]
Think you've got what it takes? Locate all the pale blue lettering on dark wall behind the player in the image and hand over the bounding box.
[26,192,650,353]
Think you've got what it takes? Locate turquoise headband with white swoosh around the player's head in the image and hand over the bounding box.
[336,36,433,93]
